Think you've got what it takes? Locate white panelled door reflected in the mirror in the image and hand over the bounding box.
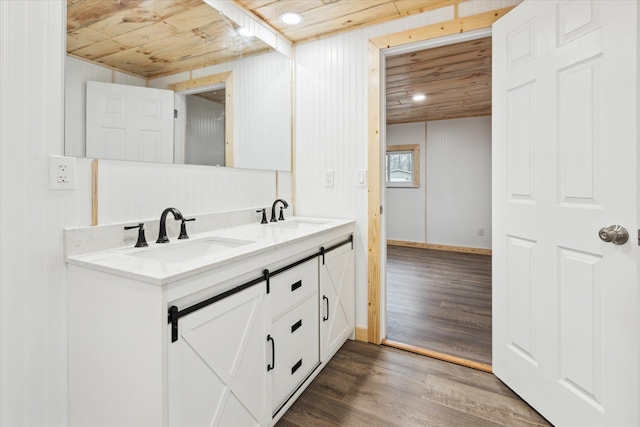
[87,82,174,163]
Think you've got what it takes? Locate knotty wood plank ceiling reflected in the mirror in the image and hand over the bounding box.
[67,0,272,79]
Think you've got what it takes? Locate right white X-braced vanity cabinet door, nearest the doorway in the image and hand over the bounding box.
[319,241,355,362]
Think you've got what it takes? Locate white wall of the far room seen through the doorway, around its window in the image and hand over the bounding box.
[386,117,491,249]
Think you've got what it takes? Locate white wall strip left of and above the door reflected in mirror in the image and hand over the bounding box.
[64,55,147,157]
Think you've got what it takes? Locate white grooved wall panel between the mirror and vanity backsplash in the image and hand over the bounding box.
[98,160,276,225]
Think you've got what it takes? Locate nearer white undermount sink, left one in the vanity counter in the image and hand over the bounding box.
[131,237,254,263]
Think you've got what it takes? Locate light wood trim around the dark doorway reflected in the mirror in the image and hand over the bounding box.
[168,71,234,168]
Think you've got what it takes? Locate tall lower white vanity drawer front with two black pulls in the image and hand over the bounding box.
[272,294,320,411]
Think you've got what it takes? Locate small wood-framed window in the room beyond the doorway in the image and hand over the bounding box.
[385,144,420,187]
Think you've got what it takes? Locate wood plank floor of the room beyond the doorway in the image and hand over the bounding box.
[387,245,491,365]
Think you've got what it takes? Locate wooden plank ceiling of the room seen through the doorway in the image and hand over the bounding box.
[386,37,491,124]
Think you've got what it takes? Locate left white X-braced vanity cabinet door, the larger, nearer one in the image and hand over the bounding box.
[168,285,273,426]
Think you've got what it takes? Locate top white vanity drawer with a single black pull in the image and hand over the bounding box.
[270,258,318,318]
